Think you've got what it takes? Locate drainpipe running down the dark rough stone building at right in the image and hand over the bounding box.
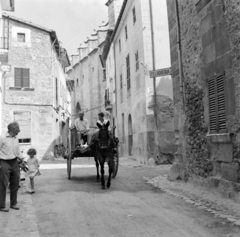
[175,0,186,112]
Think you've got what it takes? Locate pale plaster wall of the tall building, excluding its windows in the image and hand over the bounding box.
[114,0,175,163]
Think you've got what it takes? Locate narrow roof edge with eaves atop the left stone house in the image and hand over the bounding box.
[2,12,70,67]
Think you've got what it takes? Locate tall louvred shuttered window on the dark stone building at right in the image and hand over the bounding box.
[208,74,226,133]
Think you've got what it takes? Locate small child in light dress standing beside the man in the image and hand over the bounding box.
[27,148,41,193]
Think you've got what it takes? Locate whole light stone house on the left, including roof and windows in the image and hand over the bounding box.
[1,14,71,159]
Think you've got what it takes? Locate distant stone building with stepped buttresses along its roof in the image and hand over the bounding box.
[67,23,108,137]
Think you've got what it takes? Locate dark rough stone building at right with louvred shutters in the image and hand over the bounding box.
[167,0,240,184]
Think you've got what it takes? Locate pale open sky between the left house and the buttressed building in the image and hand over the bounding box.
[6,0,108,56]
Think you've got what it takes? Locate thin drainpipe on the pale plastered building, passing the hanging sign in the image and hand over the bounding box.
[149,0,158,130]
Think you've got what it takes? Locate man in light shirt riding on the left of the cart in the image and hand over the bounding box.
[74,112,89,145]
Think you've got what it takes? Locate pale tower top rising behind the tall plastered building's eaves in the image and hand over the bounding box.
[105,0,123,29]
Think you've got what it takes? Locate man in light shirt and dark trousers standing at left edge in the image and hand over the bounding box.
[0,122,21,212]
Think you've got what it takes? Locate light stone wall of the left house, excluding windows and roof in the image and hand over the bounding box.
[2,20,66,159]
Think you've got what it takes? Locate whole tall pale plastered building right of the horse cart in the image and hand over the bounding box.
[103,0,175,163]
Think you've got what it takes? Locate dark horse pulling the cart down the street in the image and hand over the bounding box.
[90,125,114,189]
